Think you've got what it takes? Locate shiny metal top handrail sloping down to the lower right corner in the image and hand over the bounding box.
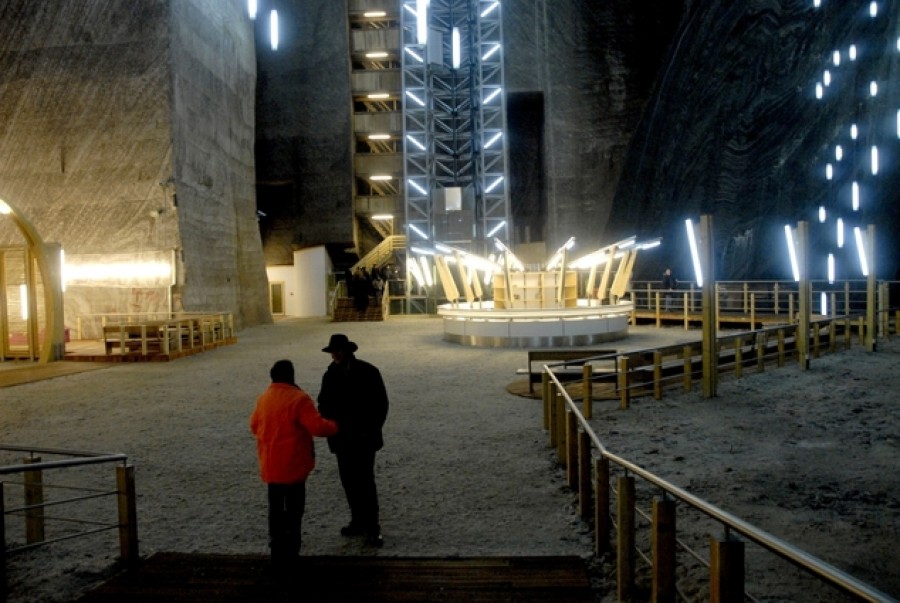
[545,365,894,602]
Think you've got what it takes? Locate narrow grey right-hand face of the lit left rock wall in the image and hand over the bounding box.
[170,0,271,325]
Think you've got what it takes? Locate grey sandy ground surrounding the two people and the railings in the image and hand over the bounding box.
[0,317,900,602]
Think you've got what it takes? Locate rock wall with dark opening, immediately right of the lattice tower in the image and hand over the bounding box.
[503,0,682,249]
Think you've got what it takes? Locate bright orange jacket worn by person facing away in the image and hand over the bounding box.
[250,383,338,484]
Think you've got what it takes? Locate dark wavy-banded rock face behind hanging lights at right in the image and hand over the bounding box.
[607,0,900,279]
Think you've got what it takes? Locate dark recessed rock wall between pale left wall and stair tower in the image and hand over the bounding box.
[256,0,353,264]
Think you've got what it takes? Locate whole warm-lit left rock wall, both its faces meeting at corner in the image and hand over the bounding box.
[0,0,271,325]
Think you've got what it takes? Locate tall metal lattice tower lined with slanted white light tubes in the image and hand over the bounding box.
[400,0,512,253]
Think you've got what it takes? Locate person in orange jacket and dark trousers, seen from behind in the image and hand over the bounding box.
[250,360,338,569]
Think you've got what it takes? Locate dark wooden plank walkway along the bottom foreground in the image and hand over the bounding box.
[79,553,594,603]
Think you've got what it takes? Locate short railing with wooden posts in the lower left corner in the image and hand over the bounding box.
[0,444,138,597]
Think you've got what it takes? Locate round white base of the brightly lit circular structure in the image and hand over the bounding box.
[438,300,633,348]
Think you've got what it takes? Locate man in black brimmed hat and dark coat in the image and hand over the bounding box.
[319,333,388,547]
